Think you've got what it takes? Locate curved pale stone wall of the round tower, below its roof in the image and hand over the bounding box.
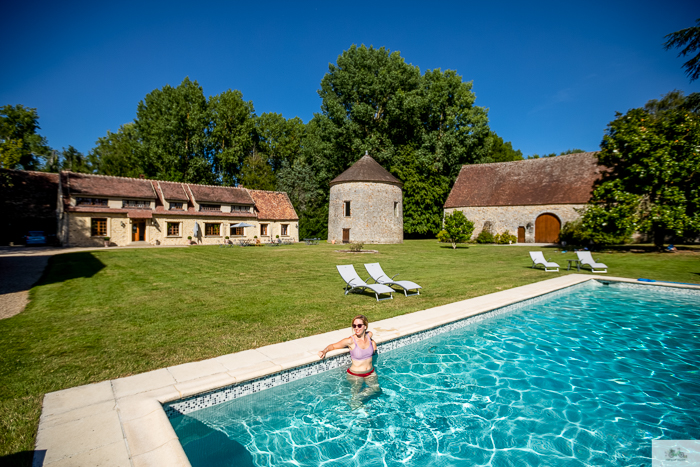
[328,182,403,243]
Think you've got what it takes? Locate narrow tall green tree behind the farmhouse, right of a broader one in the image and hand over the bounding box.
[208,89,256,185]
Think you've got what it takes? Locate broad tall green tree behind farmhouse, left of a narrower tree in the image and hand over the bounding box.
[135,78,216,183]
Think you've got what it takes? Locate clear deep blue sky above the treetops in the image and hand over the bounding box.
[0,1,700,159]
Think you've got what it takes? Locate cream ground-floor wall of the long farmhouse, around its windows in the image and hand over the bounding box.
[64,212,299,246]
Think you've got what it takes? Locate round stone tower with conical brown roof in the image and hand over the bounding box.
[328,153,403,243]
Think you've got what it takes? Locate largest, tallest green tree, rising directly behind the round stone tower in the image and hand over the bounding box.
[302,45,488,235]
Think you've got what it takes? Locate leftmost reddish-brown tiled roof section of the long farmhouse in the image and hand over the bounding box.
[63,172,158,199]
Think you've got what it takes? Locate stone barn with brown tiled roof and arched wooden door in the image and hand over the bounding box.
[444,152,601,243]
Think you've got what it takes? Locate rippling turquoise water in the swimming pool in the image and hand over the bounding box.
[171,282,700,467]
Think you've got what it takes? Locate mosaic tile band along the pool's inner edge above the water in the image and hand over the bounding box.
[163,279,700,419]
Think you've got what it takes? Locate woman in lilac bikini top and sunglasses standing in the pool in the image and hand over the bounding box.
[318,315,380,399]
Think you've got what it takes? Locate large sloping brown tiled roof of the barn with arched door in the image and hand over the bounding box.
[445,152,605,208]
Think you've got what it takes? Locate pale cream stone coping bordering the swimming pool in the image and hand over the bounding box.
[33,274,700,467]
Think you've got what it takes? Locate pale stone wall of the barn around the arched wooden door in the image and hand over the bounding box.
[445,204,586,243]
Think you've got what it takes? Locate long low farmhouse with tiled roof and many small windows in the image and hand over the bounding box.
[57,172,299,246]
